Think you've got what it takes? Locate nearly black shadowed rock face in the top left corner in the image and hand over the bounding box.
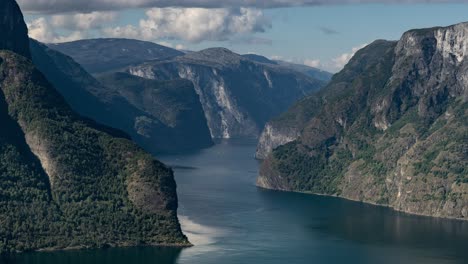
[0,0,31,58]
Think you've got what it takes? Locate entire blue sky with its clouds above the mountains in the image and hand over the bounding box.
[18,0,468,72]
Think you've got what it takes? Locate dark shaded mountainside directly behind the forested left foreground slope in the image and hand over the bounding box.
[30,40,213,153]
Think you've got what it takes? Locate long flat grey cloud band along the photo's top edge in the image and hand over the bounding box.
[18,0,465,13]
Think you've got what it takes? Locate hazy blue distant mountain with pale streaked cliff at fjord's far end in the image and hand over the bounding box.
[128,48,325,138]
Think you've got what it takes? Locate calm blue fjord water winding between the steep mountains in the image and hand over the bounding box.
[5,140,468,264]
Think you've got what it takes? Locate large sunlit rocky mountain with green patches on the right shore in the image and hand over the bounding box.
[257,23,468,220]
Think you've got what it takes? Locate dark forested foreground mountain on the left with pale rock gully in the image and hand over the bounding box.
[0,0,189,253]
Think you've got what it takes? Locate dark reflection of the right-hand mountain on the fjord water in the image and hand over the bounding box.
[259,189,468,262]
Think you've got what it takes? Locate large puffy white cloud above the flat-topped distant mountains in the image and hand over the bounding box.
[103,8,271,43]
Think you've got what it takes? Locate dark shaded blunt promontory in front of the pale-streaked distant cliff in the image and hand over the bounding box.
[98,72,213,153]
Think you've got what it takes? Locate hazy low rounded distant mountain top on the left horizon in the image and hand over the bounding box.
[49,39,184,73]
